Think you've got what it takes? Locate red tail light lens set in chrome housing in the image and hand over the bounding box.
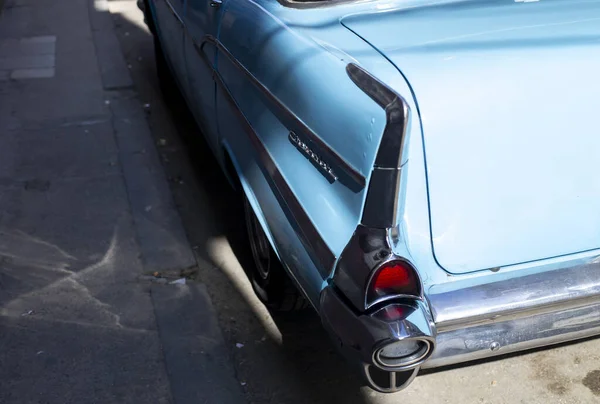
[367,260,421,302]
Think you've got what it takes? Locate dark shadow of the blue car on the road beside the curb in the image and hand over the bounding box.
[108,8,376,404]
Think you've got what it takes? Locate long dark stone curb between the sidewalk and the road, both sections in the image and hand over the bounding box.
[88,0,246,404]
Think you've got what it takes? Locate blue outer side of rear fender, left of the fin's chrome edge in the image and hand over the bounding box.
[217,1,385,296]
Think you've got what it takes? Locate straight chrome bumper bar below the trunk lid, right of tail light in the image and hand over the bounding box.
[423,258,600,367]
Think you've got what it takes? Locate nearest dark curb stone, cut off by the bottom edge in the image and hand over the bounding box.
[151,283,246,404]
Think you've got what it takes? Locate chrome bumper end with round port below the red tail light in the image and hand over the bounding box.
[320,286,437,393]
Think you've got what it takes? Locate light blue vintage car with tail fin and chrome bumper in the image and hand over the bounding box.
[140,0,600,392]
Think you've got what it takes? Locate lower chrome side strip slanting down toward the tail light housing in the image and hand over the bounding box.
[205,42,336,277]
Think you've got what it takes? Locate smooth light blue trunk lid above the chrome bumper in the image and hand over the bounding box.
[342,0,600,273]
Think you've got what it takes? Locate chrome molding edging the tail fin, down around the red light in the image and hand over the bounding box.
[334,63,409,311]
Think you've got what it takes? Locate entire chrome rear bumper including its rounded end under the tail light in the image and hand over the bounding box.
[321,258,600,392]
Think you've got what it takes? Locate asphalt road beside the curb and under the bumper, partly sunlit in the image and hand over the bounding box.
[110,0,600,404]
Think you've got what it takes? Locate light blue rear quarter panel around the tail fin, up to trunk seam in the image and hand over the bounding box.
[217,0,484,303]
